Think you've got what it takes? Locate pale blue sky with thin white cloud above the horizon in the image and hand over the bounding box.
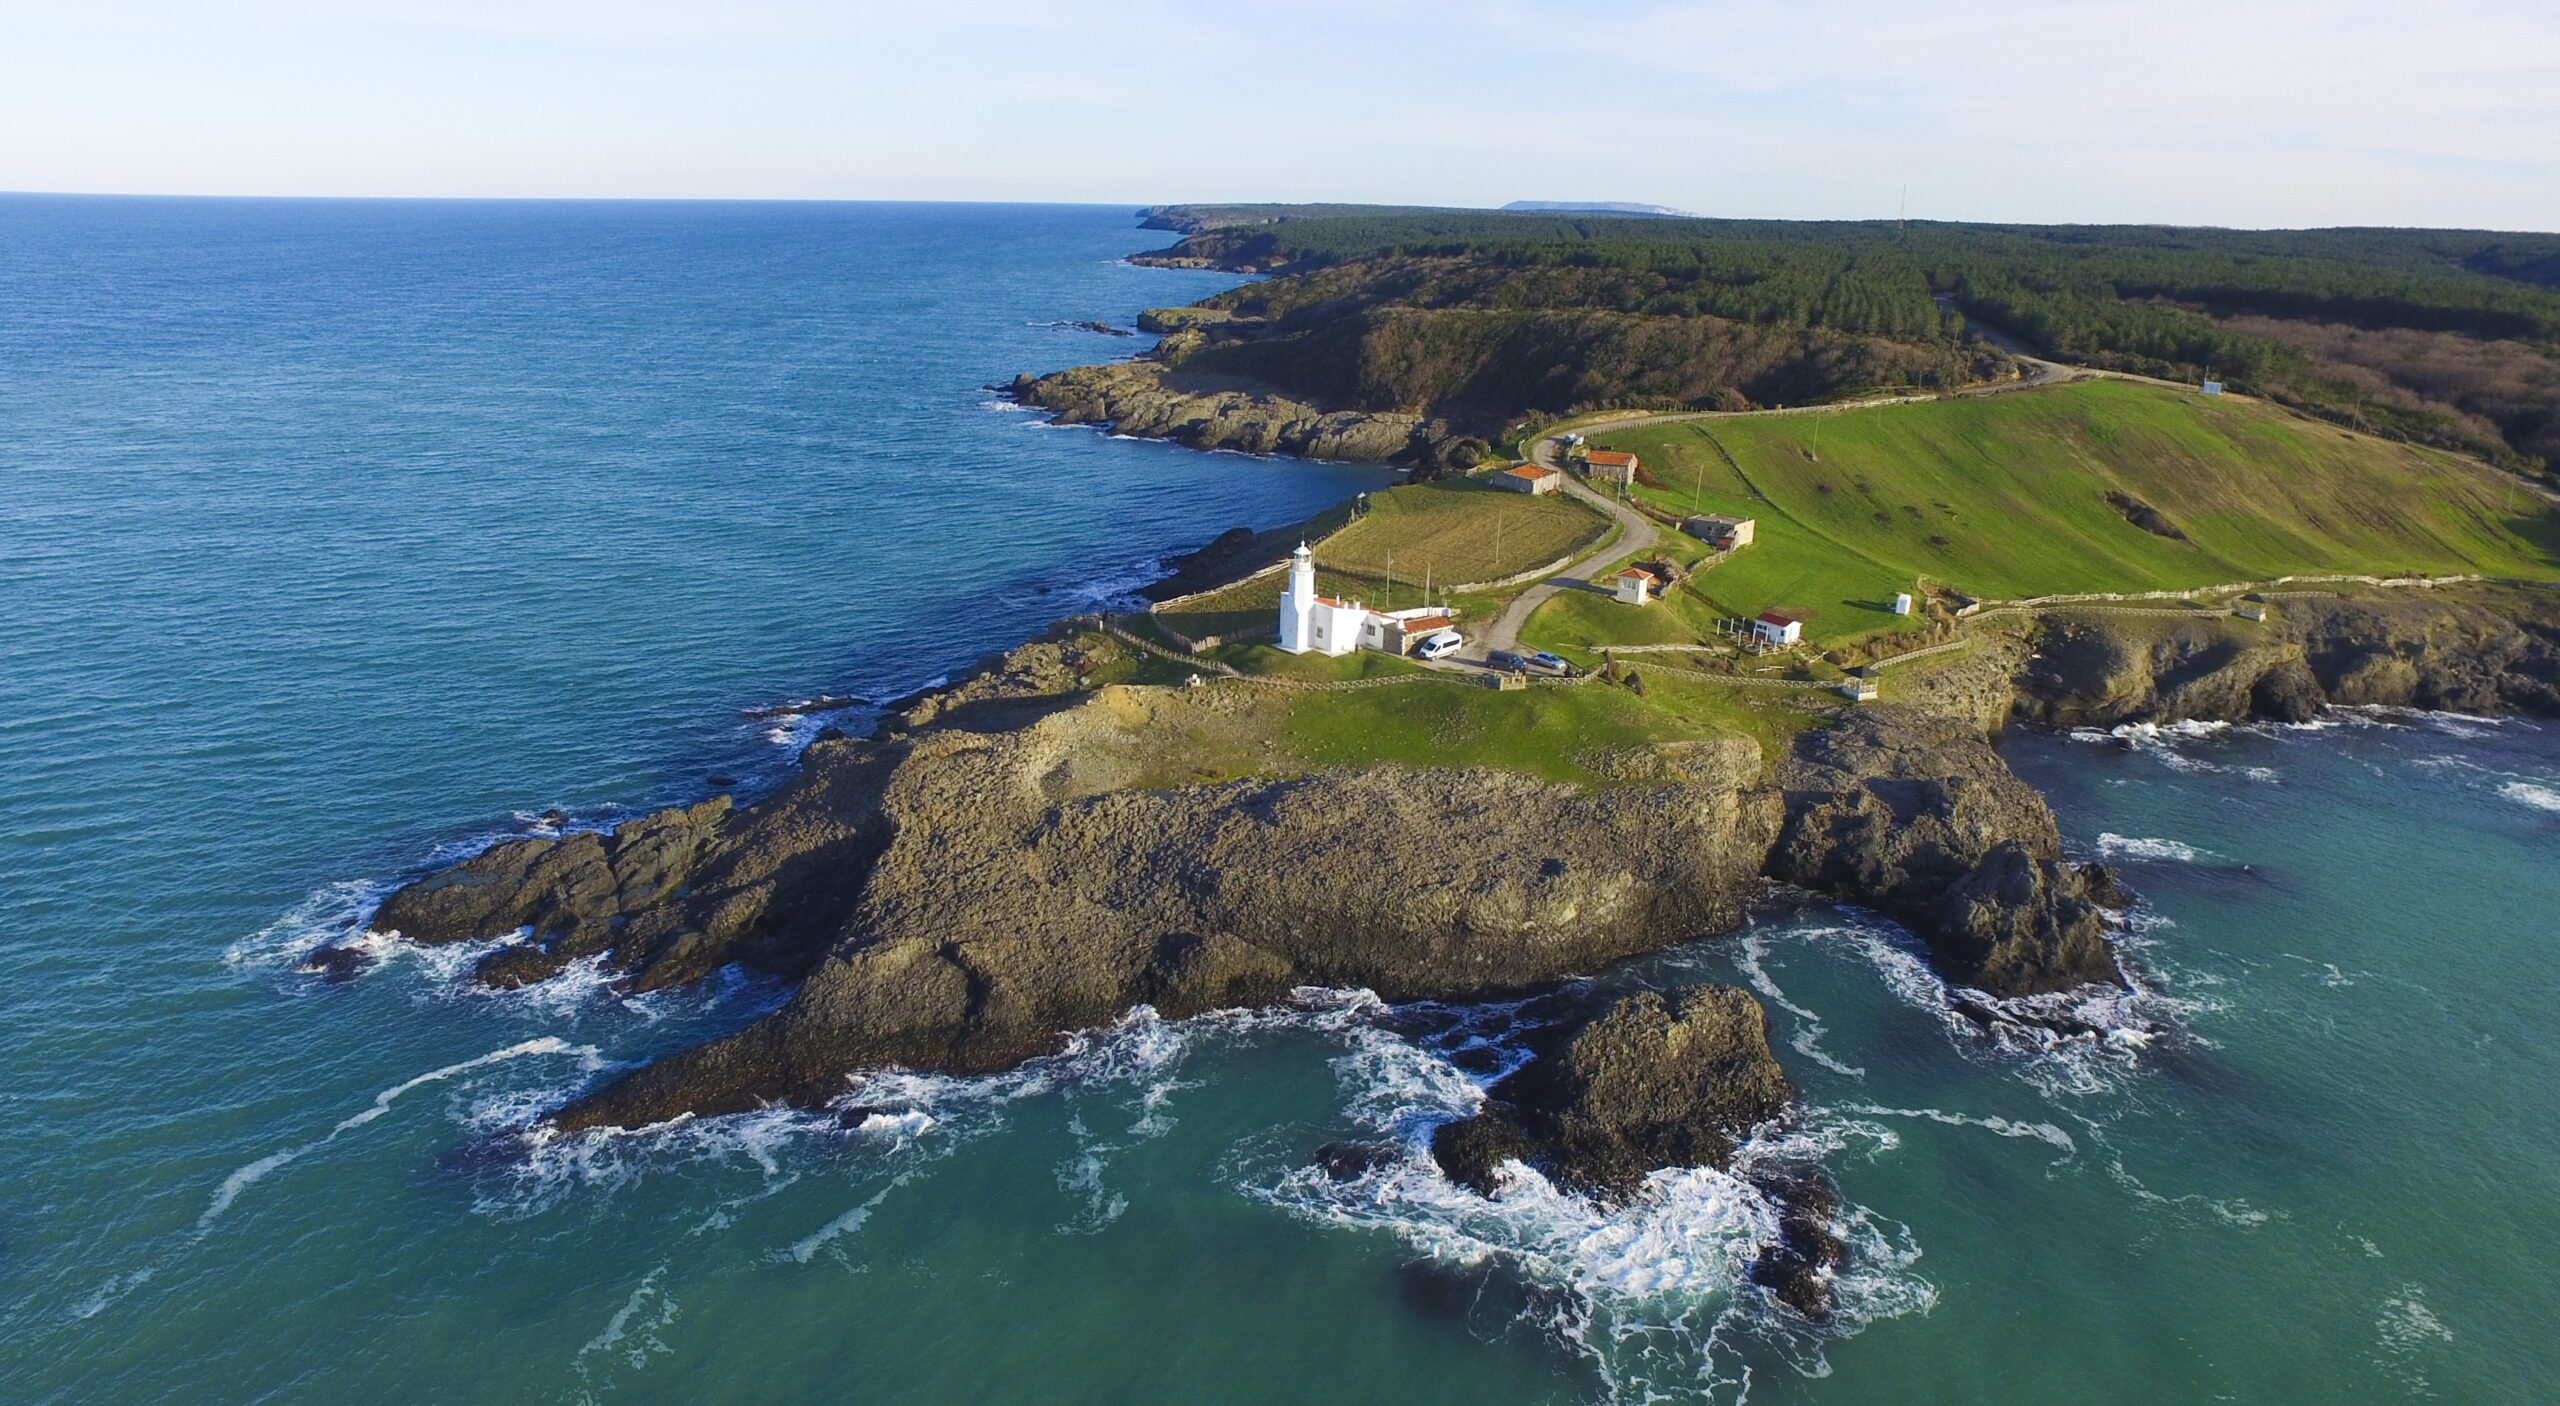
[0,0,2560,230]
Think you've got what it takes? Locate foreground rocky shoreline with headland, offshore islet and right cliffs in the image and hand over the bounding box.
[310,555,2560,1319]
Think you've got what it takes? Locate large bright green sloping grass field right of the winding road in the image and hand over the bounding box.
[1576,382,2560,643]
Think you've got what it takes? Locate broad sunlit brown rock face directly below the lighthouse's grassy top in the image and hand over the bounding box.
[561,737,1777,1127]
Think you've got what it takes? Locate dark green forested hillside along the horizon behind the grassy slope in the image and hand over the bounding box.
[1149,205,2560,471]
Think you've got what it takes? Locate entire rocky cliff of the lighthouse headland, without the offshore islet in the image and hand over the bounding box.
[320,612,2150,1142]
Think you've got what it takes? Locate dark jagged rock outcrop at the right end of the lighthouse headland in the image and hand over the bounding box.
[1769,707,2122,996]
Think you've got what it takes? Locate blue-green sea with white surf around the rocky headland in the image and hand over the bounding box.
[0,195,2560,1406]
